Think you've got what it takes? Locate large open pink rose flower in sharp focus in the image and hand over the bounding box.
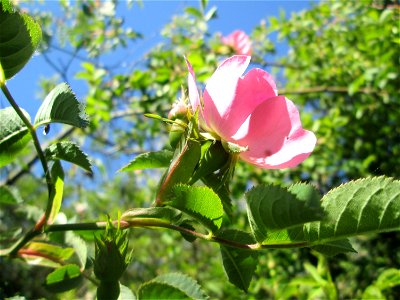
[186,55,316,169]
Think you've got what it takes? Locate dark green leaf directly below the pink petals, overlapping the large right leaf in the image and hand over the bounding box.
[246,184,322,242]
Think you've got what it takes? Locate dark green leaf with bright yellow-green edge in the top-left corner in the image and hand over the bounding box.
[0,0,42,79]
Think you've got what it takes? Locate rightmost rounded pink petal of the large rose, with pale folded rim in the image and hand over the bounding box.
[234,96,316,169]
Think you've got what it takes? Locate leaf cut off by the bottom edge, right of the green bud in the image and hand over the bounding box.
[138,273,208,299]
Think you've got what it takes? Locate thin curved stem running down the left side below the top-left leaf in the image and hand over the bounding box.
[1,84,53,254]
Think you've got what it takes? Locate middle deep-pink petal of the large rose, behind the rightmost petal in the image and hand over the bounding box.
[204,69,277,139]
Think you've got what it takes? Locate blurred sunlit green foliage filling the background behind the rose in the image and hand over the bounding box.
[0,0,400,299]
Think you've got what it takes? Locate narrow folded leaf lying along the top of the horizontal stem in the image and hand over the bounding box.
[121,207,180,222]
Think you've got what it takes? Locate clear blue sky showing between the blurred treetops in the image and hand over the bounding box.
[0,0,318,117]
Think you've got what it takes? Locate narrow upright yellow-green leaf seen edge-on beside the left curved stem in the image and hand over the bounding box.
[47,161,64,224]
